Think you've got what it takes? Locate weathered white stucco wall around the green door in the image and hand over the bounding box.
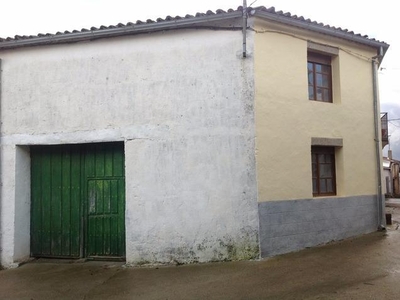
[0,30,258,265]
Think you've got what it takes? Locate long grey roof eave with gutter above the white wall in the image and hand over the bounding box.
[0,11,242,51]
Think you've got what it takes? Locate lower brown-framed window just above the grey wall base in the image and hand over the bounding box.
[311,146,336,196]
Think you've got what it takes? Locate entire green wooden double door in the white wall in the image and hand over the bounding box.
[31,143,125,258]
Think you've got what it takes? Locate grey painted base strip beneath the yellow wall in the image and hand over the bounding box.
[259,195,378,257]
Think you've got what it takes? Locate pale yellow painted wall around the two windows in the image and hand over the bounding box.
[254,19,377,202]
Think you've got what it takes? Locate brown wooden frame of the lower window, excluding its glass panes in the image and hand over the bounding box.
[311,146,336,197]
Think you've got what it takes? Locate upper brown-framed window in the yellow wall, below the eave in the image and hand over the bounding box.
[307,52,332,102]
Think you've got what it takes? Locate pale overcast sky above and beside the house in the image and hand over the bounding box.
[0,0,400,155]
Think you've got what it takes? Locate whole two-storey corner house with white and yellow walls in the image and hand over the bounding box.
[0,7,389,267]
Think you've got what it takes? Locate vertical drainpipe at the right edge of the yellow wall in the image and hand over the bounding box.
[372,47,386,231]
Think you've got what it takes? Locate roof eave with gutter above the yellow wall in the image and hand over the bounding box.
[251,10,389,54]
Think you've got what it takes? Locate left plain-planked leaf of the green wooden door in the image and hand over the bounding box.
[31,146,81,257]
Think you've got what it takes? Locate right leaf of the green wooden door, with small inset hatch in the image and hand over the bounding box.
[85,144,125,258]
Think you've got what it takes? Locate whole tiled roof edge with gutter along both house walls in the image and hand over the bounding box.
[0,6,389,50]
